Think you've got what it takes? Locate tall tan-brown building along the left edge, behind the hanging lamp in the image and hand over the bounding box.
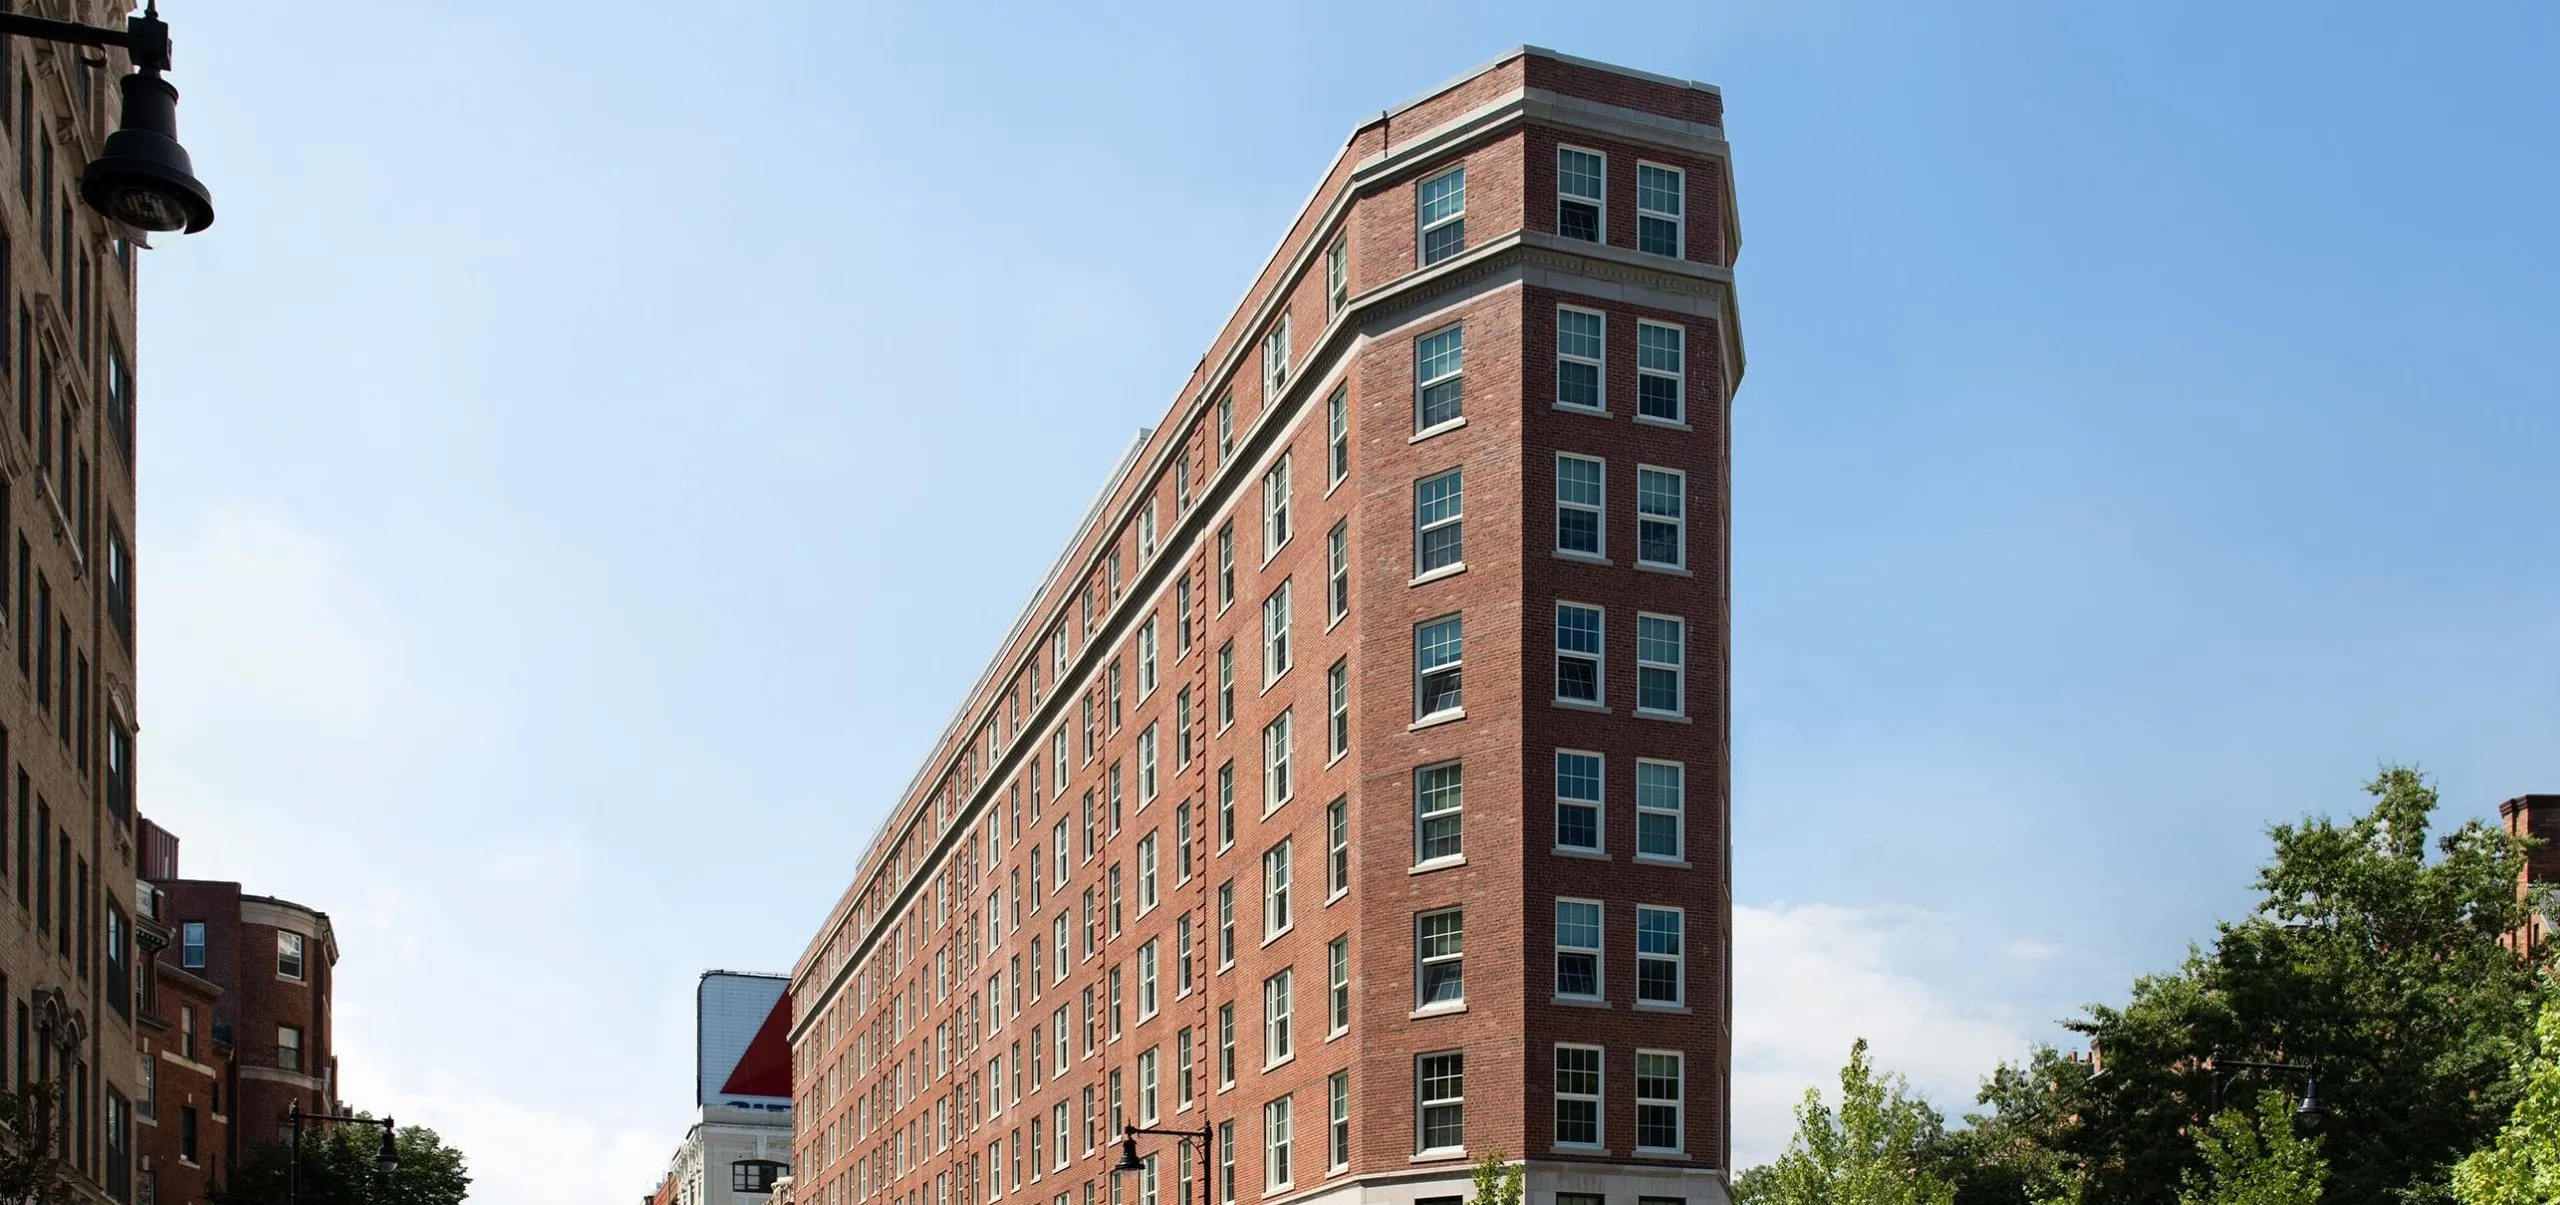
[0,0,161,1200]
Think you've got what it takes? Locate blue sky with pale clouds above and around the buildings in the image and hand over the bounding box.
[138,0,2560,1205]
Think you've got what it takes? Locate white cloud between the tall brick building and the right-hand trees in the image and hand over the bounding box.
[1733,903,2028,1167]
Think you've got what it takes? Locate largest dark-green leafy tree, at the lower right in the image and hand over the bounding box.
[1969,768,2537,1205]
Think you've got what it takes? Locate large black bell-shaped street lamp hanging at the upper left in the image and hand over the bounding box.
[0,0,212,235]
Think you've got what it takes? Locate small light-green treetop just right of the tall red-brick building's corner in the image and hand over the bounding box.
[1733,1039,1956,1205]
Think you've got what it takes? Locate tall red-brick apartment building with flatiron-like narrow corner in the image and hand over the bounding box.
[791,49,1743,1205]
